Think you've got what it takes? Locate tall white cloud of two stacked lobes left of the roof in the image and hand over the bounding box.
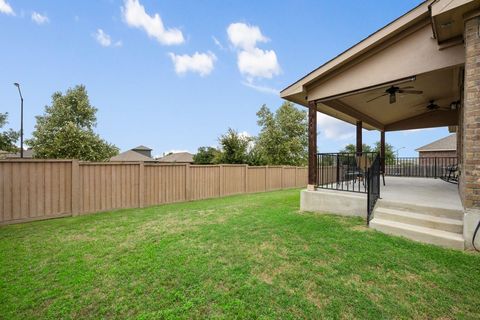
[227,23,281,83]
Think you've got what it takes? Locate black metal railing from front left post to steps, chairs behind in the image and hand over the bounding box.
[317,152,378,193]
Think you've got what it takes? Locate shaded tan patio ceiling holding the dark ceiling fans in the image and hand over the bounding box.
[317,68,461,131]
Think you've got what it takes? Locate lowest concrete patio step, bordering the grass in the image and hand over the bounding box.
[370,217,465,250]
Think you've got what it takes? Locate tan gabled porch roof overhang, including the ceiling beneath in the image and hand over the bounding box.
[281,0,480,131]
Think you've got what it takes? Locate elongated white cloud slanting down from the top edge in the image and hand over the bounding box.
[122,0,185,45]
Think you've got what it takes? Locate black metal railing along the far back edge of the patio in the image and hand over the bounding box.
[385,157,458,181]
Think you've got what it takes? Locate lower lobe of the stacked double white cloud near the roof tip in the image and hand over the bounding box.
[237,48,280,79]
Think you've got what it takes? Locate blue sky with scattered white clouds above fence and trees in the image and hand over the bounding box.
[0,0,448,156]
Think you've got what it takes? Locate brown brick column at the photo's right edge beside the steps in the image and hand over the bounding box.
[460,16,480,209]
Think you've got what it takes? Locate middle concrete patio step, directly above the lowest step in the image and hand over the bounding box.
[374,207,463,234]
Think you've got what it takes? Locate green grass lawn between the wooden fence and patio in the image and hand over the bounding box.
[0,190,480,319]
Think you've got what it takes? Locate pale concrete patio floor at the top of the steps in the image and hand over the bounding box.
[380,176,463,211]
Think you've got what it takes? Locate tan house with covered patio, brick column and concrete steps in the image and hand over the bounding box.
[280,0,480,249]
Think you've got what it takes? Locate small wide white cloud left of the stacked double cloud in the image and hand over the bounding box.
[169,52,217,77]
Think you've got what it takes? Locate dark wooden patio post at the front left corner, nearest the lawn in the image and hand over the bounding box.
[307,101,317,191]
